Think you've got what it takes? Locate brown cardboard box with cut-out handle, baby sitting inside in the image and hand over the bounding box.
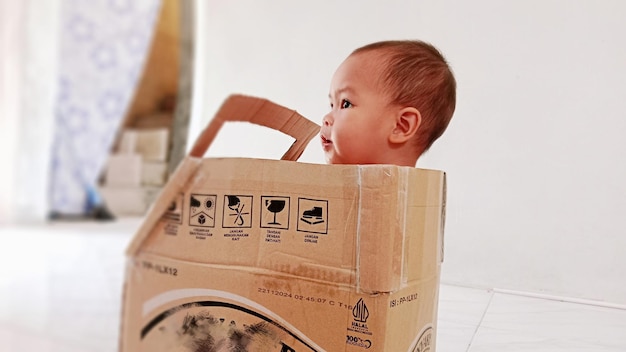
[121,96,445,352]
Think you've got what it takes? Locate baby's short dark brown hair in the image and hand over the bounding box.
[352,40,456,151]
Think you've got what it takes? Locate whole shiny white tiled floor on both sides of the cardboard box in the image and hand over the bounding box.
[0,220,626,352]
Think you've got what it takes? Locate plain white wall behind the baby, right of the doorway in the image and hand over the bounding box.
[191,0,626,304]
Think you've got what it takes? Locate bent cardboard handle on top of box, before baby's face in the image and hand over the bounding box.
[189,95,320,161]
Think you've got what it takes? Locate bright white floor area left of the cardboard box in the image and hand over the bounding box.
[0,220,139,352]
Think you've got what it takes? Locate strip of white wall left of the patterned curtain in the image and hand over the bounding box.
[0,0,61,224]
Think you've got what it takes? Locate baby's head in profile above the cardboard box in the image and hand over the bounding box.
[321,41,456,166]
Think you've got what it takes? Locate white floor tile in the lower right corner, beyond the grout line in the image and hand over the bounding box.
[469,294,626,352]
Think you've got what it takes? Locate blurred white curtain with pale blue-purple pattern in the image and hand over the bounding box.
[50,0,160,215]
